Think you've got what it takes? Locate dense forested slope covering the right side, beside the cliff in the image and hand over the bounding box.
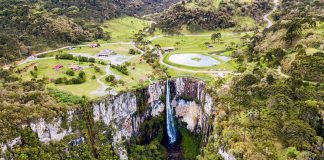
[199,1,324,160]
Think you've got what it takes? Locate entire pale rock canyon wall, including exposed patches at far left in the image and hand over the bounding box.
[0,78,214,159]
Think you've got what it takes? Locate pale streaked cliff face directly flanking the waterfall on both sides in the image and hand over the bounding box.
[93,78,213,159]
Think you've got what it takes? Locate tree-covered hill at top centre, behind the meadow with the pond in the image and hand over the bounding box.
[155,1,270,33]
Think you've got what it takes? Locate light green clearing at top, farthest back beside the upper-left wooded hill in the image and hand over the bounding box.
[102,17,150,42]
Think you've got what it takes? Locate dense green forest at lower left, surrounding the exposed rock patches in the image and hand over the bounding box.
[0,69,121,160]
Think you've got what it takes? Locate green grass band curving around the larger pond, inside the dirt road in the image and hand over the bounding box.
[163,53,237,70]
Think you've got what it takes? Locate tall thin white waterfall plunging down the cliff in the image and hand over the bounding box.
[166,80,177,144]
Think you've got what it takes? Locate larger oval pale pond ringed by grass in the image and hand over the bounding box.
[169,53,220,67]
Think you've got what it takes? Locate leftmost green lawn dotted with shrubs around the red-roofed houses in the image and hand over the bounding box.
[19,59,105,98]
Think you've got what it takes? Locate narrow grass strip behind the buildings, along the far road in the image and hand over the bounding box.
[69,43,134,56]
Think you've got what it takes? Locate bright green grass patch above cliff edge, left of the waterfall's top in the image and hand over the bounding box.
[102,57,153,92]
